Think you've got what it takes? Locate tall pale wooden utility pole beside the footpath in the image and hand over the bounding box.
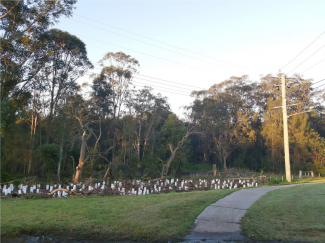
[281,74,291,182]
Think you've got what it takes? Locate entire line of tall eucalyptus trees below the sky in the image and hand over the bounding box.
[0,0,325,181]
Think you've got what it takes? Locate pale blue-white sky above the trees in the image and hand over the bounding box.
[55,0,325,116]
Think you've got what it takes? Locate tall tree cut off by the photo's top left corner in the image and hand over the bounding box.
[0,0,76,175]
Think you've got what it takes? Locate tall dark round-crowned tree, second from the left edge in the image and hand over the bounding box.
[35,29,93,143]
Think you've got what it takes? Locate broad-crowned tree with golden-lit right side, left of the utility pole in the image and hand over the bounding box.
[190,76,258,169]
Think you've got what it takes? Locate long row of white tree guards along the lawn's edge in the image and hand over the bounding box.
[0,178,258,197]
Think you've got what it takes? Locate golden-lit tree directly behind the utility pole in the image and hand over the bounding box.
[261,76,321,171]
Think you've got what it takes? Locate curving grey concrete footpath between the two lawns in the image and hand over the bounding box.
[184,184,299,243]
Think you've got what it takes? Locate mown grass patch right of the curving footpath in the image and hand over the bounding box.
[242,184,325,242]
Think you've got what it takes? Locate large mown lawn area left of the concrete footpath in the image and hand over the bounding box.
[0,190,235,242]
